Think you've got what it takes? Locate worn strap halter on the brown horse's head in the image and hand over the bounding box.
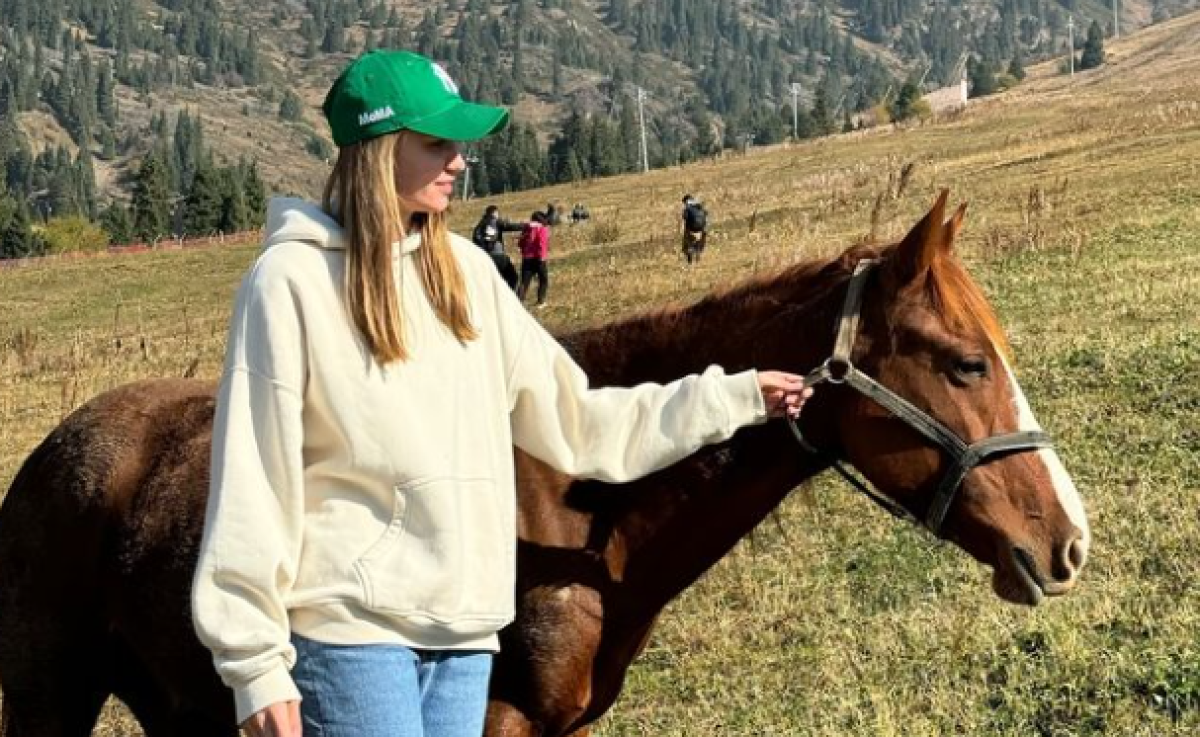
[787,259,1054,538]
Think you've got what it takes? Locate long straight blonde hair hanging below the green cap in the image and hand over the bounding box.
[322,131,479,364]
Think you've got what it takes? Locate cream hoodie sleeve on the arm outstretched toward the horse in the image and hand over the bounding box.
[509,309,767,483]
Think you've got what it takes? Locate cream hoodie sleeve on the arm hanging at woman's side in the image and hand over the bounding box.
[192,262,305,724]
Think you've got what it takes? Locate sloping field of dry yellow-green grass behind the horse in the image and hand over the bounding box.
[0,13,1200,737]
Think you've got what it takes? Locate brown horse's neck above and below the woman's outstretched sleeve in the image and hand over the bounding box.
[568,262,842,616]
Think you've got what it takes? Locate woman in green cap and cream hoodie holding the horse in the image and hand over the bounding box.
[192,52,809,737]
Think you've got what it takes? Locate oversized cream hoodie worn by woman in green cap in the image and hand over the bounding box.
[192,199,766,723]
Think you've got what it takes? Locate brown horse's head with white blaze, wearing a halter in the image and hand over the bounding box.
[797,192,1090,605]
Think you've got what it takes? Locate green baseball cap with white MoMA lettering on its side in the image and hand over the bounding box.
[322,49,509,146]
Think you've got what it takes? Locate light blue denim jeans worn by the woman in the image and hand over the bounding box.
[292,635,492,737]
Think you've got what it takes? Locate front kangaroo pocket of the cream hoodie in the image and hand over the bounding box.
[354,479,516,627]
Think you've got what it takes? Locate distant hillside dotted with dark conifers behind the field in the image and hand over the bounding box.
[0,0,1196,216]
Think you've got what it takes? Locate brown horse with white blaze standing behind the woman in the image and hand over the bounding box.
[0,193,1088,737]
